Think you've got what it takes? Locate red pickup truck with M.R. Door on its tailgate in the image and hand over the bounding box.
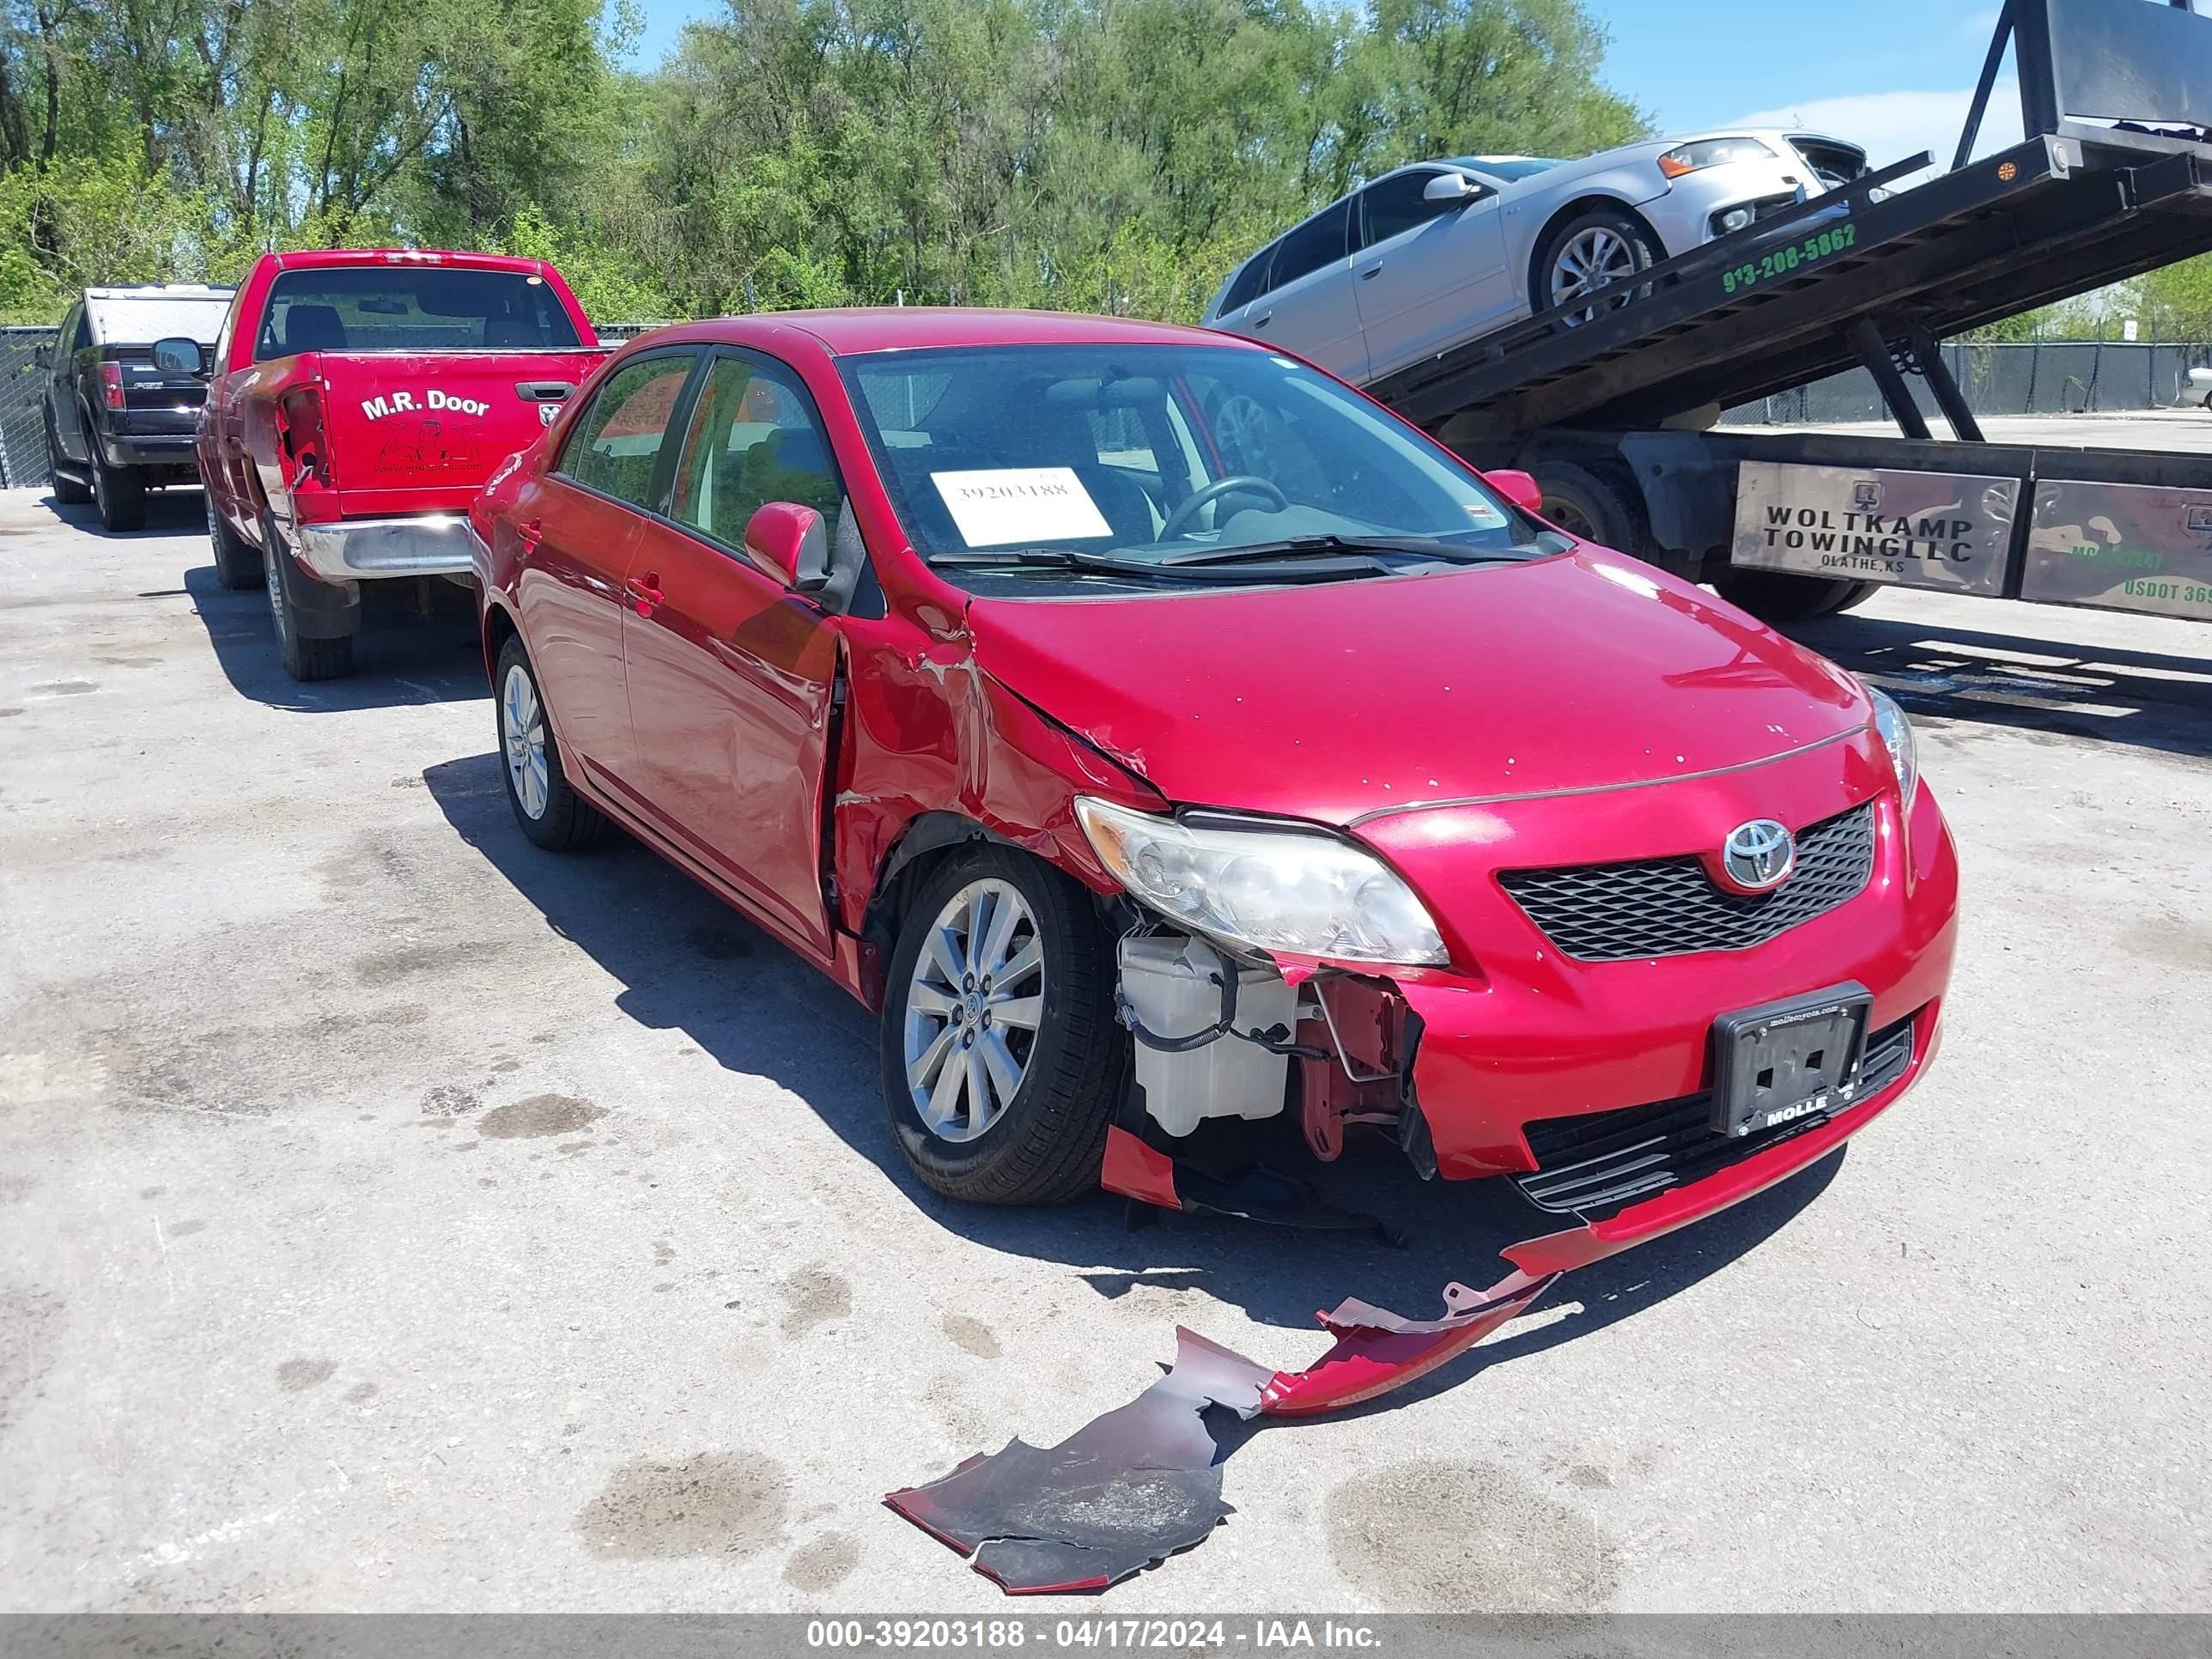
[197,250,604,679]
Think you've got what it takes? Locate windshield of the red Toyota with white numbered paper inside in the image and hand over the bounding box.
[841,345,1564,584]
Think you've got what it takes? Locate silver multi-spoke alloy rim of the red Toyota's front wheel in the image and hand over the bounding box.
[905,878,1044,1141]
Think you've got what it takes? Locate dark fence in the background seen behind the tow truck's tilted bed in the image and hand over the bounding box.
[1721,341,2212,427]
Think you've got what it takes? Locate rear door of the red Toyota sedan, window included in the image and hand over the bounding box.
[508,347,696,787]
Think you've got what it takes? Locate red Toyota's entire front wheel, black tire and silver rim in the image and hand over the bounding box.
[880,842,1130,1203]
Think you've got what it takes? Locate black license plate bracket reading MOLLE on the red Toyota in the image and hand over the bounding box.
[1712,980,1874,1139]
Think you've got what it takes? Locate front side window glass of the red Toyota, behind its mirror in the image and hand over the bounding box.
[671,356,845,549]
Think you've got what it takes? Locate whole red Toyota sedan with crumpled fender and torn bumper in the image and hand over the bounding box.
[471,310,1958,1270]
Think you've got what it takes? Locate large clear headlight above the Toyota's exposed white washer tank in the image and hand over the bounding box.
[1075,796,1447,964]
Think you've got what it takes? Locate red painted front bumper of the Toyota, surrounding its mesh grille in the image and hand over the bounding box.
[1360,734,1958,1179]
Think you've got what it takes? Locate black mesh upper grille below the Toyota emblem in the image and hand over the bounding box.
[1498,801,1874,963]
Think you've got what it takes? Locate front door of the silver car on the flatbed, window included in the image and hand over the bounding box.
[1352,168,1520,376]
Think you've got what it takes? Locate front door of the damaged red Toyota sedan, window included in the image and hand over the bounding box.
[622,349,845,957]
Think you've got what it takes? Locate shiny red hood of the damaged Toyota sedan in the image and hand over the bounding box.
[969,546,1871,825]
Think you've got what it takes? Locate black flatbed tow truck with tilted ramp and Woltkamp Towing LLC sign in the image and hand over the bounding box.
[1367,0,2212,622]
